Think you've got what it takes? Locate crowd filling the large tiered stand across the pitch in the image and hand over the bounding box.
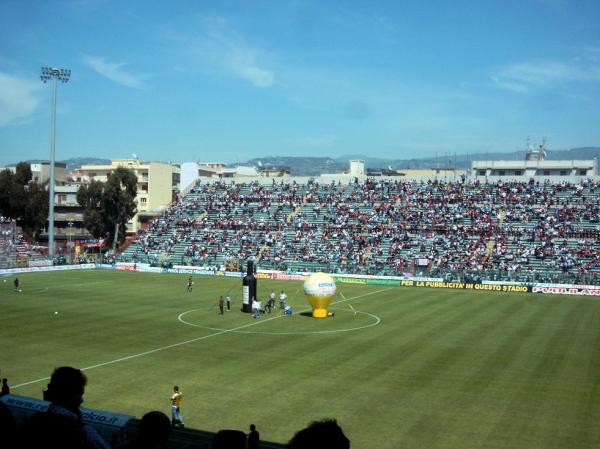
[120,178,600,281]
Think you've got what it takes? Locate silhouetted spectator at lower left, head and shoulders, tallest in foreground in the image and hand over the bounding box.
[19,366,110,449]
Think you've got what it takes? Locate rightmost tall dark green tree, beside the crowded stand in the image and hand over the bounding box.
[102,167,137,251]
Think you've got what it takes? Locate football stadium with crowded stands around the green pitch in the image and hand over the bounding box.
[0,178,600,449]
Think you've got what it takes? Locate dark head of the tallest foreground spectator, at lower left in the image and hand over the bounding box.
[44,366,87,413]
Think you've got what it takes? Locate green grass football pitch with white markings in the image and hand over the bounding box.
[0,270,600,449]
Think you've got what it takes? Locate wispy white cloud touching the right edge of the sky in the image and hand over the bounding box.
[491,57,600,93]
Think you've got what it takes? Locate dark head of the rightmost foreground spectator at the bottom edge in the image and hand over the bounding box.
[287,419,350,449]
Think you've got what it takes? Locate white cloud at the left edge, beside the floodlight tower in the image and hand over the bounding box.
[0,72,42,126]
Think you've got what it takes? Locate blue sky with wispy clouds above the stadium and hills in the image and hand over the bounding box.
[0,0,600,165]
